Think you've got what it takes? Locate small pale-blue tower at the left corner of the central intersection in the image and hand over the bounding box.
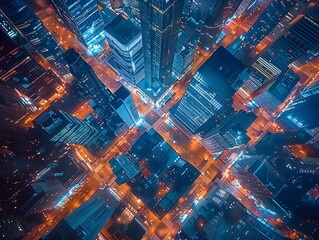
[110,87,140,128]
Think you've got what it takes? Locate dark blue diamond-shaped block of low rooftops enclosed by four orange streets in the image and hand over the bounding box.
[122,129,200,218]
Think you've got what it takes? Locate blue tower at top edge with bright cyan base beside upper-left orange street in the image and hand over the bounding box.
[53,0,104,47]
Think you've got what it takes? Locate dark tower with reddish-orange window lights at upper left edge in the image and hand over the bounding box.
[0,31,61,108]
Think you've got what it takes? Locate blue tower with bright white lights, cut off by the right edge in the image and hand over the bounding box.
[276,93,319,130]
